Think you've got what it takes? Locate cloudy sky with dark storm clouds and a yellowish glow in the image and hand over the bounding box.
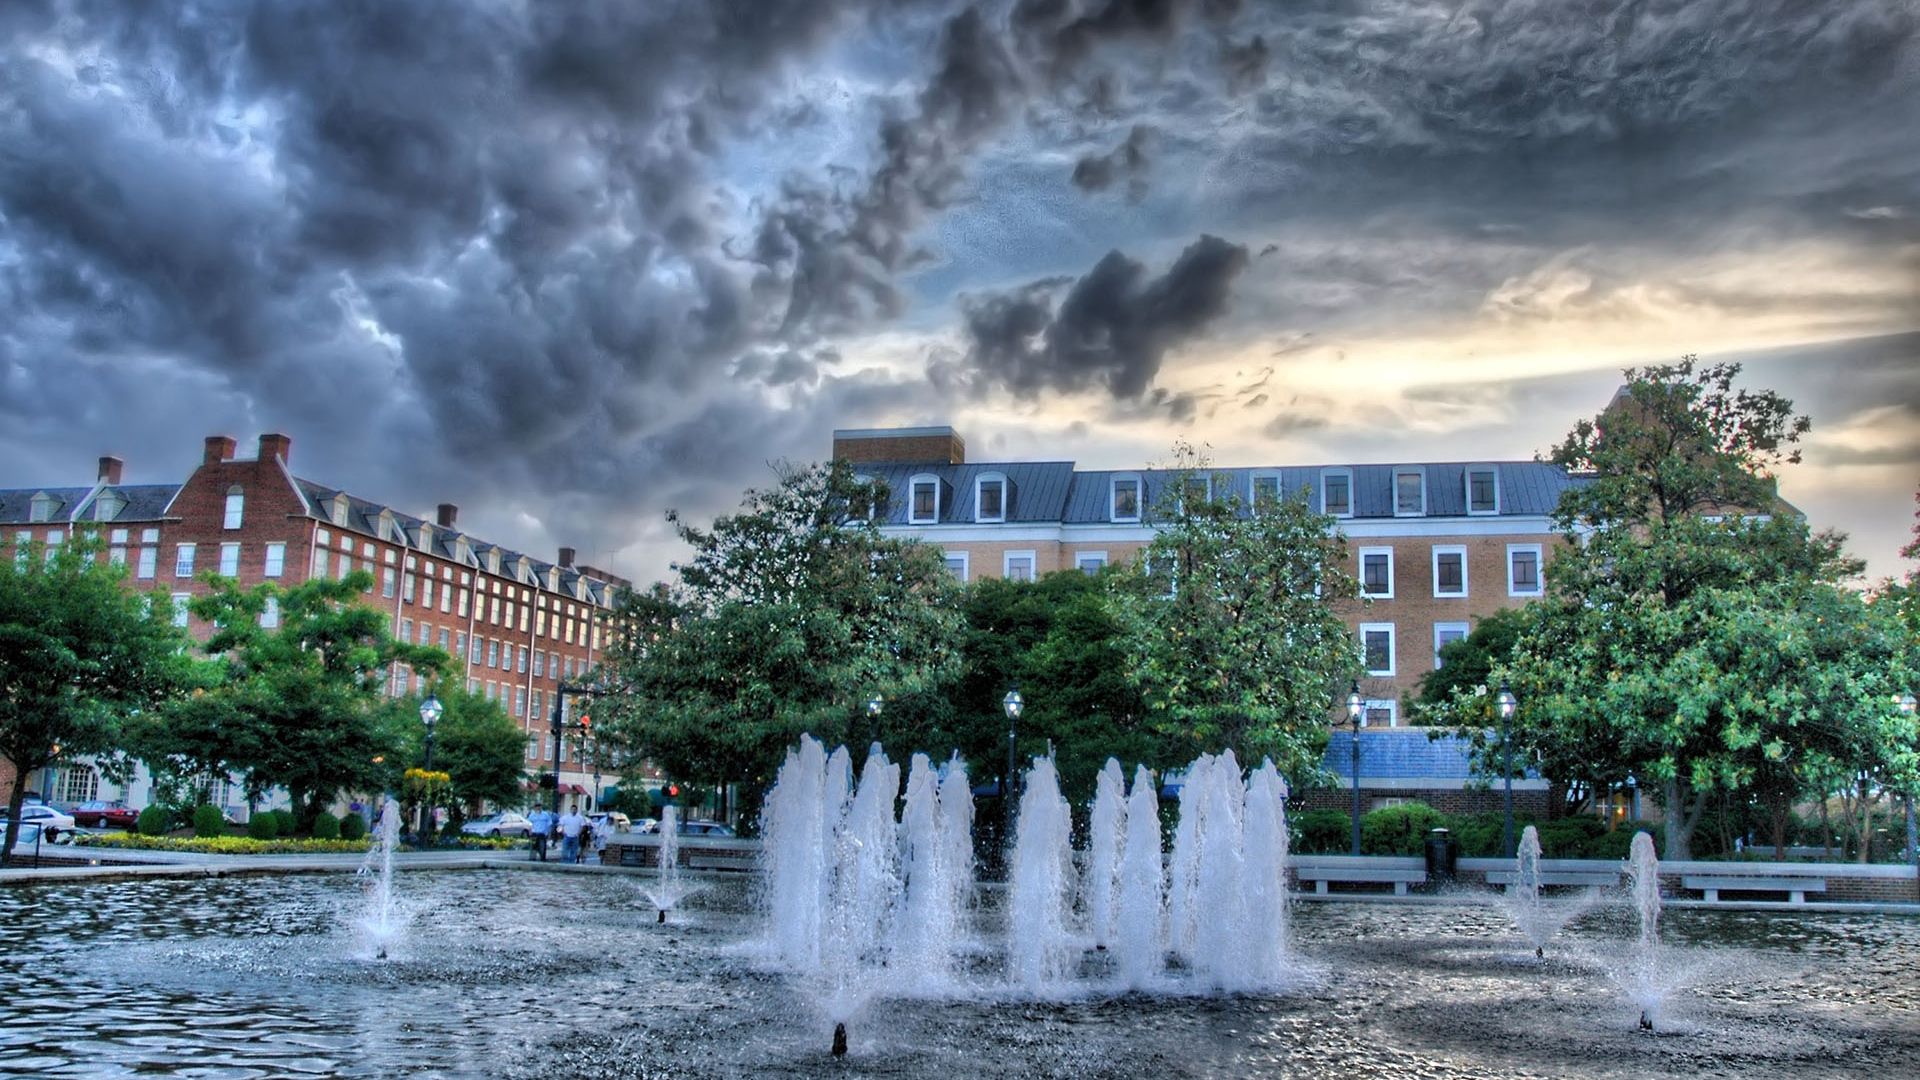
[0,0,1920,578]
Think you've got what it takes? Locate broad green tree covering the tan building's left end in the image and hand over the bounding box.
[595,461,962,786]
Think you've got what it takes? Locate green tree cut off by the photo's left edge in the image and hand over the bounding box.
[0,534,192,865]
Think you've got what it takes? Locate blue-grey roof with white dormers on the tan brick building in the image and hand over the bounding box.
[854,461,1588,525]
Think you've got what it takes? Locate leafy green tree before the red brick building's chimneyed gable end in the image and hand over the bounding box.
[129,571,447,821]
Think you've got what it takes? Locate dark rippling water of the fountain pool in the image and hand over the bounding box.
[0,871,1920,1078]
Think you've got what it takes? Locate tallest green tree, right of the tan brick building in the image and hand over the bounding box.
[1450,357,1903,859]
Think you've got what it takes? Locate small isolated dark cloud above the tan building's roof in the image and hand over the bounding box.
[962,236,1246,399]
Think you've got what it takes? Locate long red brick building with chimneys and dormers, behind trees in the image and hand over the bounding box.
[0,434,628,809]
